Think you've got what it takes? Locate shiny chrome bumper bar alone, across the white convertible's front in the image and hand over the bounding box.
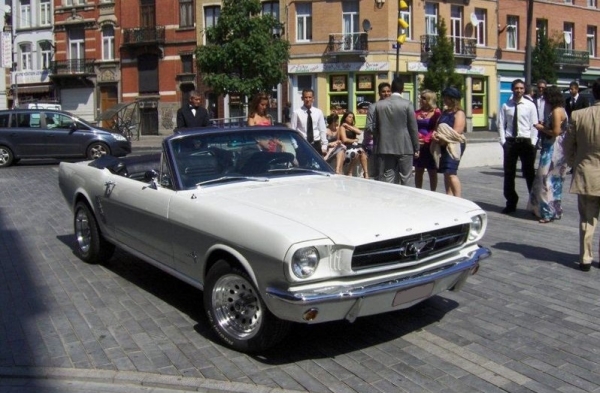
[266,247,492,306]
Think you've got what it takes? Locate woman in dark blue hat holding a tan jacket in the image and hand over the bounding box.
[431,87,467,198]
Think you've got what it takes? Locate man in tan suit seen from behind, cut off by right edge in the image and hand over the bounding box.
[563,78,600,271]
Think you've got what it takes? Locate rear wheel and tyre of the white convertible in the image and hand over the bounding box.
[73,202,115,263]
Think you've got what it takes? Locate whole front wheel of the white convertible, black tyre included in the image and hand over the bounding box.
[204,260,290,352]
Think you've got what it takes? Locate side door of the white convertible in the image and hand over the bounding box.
[101,175,175,267]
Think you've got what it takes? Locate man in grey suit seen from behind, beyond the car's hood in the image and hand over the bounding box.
[367,78,419,185]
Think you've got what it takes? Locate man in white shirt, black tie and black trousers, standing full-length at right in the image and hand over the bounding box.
[498,79,538,214]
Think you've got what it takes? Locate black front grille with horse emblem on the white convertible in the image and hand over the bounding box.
[352,224,469,271]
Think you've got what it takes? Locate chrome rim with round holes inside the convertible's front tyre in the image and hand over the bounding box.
[211,274,263,340]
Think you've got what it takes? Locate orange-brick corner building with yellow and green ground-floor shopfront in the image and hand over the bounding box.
[284,0,498,131]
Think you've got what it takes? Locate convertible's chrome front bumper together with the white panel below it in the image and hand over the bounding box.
[265,247,491,323]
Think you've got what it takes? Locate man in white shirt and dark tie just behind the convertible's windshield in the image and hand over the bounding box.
[290,89,327,155]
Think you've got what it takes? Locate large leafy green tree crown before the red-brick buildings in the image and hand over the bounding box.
[196,0,290,101]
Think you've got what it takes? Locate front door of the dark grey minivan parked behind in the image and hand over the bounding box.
[43,111,91,157]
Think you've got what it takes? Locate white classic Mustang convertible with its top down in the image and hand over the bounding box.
[59,127,490,352]
